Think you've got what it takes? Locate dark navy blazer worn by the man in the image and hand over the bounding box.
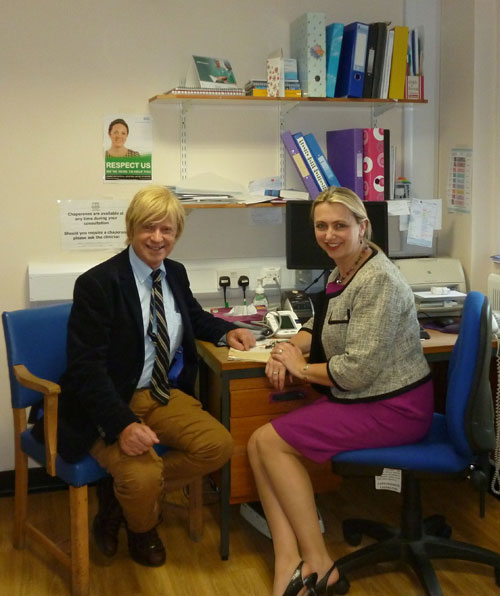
[51,249,234,461]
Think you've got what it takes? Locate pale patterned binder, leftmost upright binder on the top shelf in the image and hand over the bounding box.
[290,12,326,97]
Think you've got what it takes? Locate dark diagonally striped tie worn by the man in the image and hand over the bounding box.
[148,269,170,405]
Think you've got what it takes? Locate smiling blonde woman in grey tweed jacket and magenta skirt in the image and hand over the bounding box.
[248,187,434,596]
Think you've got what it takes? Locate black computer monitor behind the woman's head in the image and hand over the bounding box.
[286,201,389,269]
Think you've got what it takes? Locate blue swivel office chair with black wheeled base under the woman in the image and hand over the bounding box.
[332,292,500,596]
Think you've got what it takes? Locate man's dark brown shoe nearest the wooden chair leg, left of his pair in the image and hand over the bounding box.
[92,477,124,557]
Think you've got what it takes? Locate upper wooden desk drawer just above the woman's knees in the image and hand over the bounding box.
[230,378,319,418]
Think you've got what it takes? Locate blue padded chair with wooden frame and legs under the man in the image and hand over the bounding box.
[2,304,203,596]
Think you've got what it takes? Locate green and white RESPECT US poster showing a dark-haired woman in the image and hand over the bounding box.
[103,114,153,181]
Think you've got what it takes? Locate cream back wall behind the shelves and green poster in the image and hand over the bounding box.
[0,0,422,471]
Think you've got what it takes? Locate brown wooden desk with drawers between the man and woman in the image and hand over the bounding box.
[198,330,457,559]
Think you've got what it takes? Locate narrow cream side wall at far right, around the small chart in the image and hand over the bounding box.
[439,0,500,293]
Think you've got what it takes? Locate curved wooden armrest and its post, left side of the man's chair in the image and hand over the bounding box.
[13,364,61,476]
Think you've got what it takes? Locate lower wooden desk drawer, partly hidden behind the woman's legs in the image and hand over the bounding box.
[230,415,340,504]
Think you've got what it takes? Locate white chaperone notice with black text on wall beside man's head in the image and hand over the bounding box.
[58,199,130,250]
